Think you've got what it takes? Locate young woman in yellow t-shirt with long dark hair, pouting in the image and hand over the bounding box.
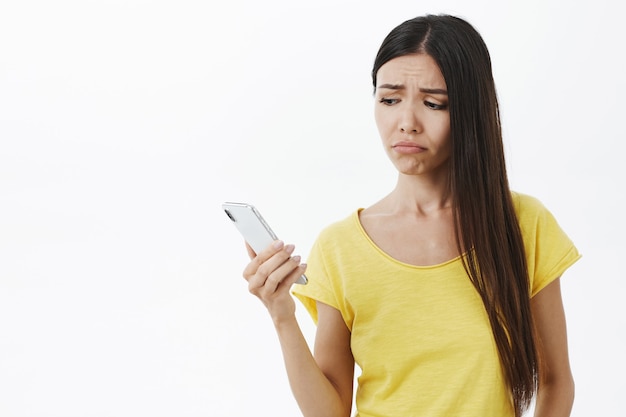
[243,15,580,417]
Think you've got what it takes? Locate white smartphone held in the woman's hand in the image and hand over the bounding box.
[222,203,309,285]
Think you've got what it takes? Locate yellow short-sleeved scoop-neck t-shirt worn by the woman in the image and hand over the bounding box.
[293,193,580,417]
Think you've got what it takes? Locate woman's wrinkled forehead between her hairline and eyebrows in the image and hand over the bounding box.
[376,54,446,89]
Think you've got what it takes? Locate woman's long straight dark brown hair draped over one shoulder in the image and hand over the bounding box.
[372,15,538,416]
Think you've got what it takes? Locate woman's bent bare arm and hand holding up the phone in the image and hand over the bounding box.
[243,242,354,417]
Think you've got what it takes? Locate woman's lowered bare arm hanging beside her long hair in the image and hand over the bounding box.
[531,279,574,417]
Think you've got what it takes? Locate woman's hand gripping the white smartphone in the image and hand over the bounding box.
[243,240,306,324]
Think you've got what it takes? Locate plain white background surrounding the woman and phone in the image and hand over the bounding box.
[0,0,626,417]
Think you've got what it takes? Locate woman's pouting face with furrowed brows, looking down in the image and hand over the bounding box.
[374,54,451,175]
